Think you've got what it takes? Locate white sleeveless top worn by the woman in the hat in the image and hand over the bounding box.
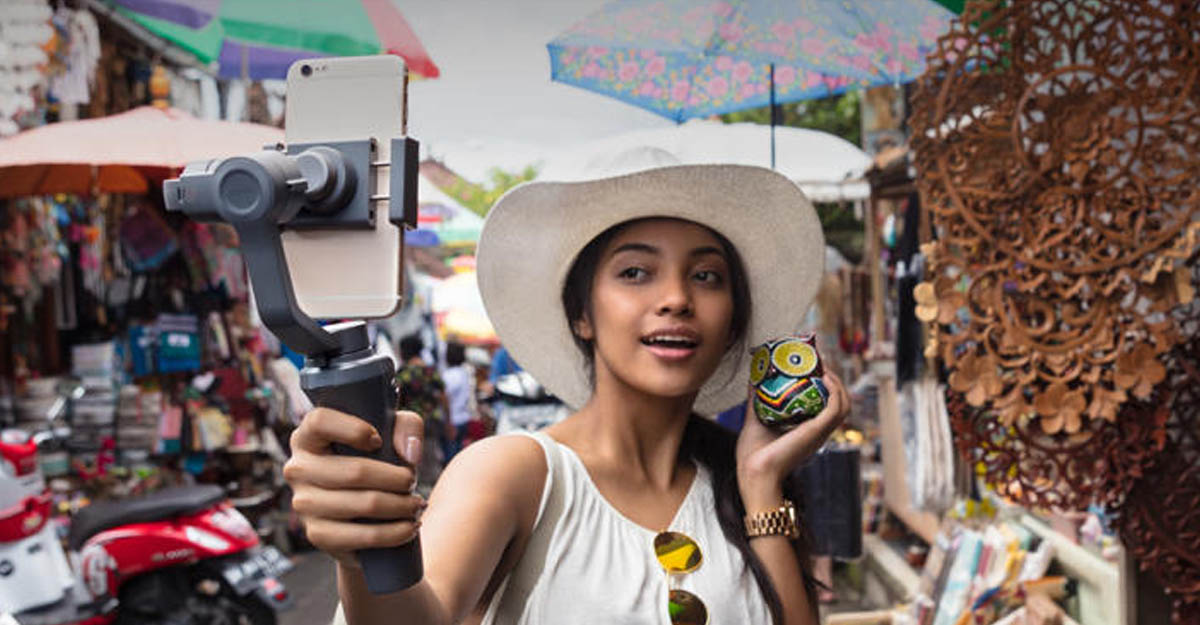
[482,432,770,625]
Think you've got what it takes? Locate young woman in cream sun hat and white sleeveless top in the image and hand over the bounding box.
[284,158,848,625]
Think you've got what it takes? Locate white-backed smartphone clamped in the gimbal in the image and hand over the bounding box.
[282,55,408,319]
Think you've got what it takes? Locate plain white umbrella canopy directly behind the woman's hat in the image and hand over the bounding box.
[538,120,871,202]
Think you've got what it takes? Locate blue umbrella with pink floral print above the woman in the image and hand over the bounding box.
[547,0,954,161]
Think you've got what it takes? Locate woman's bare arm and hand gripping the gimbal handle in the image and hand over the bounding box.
[289,414,547,625]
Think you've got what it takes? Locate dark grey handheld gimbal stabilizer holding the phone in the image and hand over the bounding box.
[163,133,424,594]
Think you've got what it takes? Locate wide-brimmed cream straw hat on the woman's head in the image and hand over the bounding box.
[476,149,824,415]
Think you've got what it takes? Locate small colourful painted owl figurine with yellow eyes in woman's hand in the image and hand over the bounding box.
[750,333,829,429]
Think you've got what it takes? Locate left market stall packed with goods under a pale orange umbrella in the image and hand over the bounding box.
[0,35,314,556]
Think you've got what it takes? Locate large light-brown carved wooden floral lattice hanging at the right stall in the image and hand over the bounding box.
[912,0,1200,507]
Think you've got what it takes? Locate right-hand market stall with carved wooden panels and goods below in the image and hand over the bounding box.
[833,1,1200,625]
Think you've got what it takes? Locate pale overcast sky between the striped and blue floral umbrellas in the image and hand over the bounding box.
[394,0,673,181]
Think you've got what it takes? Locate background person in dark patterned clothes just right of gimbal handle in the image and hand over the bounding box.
[396,335,452,493]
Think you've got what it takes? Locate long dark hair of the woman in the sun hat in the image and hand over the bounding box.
[563,220,817,624]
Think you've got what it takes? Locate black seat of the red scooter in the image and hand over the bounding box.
[67,485,227,551]
